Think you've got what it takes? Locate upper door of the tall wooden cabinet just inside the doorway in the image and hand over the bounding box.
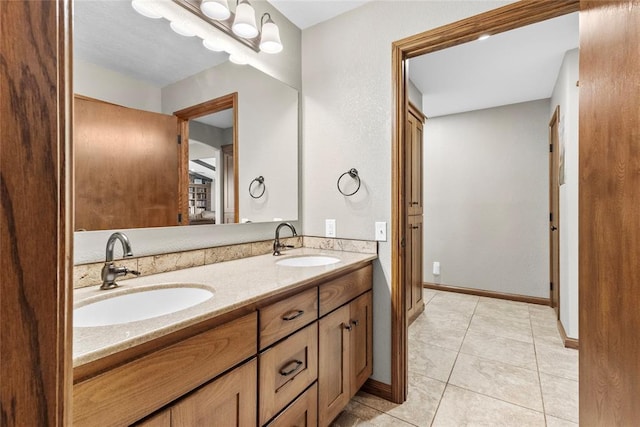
[405,104,424,215]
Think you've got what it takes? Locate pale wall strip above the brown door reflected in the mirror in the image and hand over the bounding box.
[73,59,162,113]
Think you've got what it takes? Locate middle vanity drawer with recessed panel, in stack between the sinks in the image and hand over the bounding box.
[259,322,318,425]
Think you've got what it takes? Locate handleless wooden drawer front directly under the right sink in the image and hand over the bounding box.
[320,264,373,317]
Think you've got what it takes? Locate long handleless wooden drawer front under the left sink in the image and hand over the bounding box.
[73,312,258,427]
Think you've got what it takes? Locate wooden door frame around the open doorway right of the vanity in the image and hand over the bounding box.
[391,0,580,403]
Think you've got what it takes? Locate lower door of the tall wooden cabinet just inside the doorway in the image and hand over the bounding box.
[405,215,424,323]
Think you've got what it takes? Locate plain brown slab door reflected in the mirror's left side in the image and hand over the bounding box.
[73,96,179,230]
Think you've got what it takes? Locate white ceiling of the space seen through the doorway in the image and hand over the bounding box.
[409,12,578,117]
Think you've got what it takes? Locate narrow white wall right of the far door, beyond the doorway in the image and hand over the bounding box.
[549,49,579,338]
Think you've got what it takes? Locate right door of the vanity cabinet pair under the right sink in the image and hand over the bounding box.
[349,291,373,396]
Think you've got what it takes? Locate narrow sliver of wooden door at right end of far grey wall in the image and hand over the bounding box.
[549,106,564,319]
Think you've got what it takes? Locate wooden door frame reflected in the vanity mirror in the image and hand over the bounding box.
[173,92,240,225]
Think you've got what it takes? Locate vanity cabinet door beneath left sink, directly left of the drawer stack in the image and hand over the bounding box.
[171,359,258,427]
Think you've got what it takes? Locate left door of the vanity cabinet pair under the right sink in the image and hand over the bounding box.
[318,305,351,427]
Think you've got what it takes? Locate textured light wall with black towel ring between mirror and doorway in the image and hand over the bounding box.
[302,1,508,384]
